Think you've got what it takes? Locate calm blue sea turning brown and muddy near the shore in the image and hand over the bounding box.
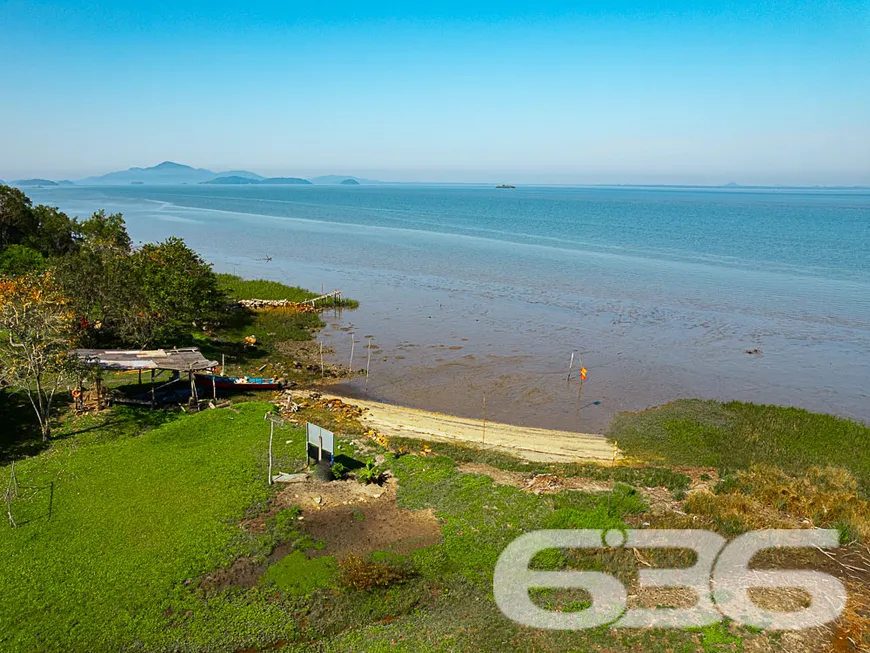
[23,186,870,430]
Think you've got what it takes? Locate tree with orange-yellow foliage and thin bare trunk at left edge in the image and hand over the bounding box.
[0,272,77,440]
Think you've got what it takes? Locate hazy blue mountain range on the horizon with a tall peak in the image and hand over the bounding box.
[73,161,383,186]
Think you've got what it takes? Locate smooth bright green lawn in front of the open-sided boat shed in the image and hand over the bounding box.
[0,403,312,651]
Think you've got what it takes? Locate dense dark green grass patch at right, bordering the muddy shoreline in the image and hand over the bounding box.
[607,399,870,487]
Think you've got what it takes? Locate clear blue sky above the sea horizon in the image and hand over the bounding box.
[0,0,870,185]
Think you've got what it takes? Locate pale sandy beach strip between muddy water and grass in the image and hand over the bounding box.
[324,395,613,462]
